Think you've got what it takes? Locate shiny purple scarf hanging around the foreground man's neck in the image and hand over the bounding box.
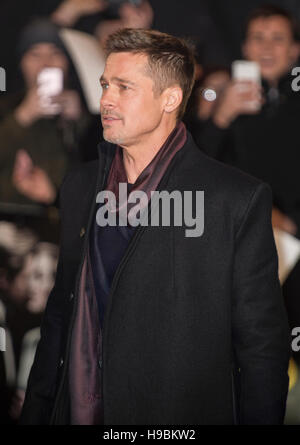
[69,123,186,425]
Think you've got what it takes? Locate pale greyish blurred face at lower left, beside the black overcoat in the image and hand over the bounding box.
[27,251,56,313]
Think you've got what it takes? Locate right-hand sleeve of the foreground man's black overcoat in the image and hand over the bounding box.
[232,184,290,424]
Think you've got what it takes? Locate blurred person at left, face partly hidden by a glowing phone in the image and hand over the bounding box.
[0,19,87,204]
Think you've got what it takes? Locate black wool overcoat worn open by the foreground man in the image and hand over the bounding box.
[22,134,289,425]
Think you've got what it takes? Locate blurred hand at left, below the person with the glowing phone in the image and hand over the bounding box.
[12,150,56,204]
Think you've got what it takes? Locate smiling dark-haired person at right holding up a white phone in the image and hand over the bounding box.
[196,6,300,237]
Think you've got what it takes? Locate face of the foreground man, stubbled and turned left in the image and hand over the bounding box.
[100,53,164,147]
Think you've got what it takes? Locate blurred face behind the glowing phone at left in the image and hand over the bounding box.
[21,43,68,88]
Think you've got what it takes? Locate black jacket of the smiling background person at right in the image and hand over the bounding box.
[194,75,300,237]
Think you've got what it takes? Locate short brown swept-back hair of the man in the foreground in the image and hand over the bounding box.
[106,28,195,119]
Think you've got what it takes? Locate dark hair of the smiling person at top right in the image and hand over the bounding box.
[244,5,300,41]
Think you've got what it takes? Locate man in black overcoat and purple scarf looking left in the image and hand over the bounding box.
[21,29,290,425]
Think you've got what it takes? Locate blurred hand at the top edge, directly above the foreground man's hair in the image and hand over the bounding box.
[119,0,153,29]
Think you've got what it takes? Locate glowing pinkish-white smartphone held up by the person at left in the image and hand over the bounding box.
[37,68,64,114]
